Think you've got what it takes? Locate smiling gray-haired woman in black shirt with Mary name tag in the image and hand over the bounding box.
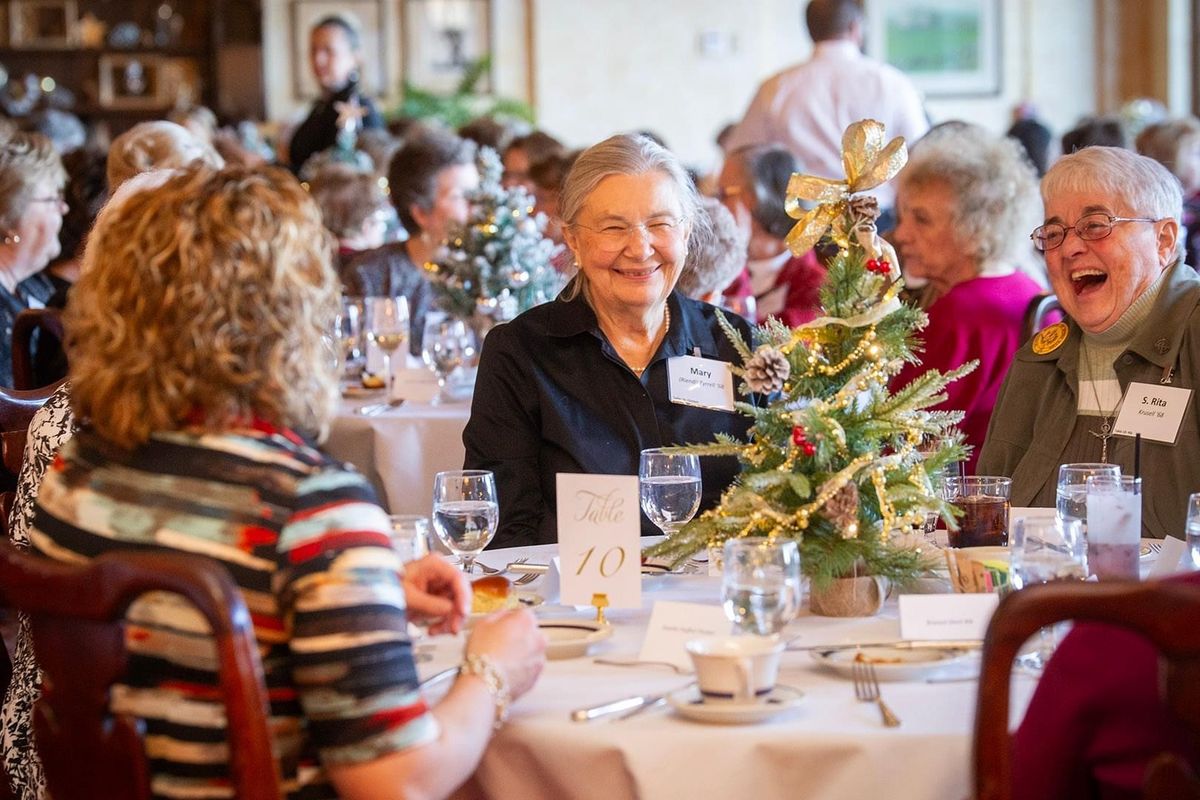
[463,136,749,547]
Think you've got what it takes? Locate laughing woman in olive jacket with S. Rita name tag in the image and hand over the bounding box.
[979,146,1200,537]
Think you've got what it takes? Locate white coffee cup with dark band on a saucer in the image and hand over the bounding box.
[686,636,784,703]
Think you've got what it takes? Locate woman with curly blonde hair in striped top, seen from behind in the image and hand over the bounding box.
[8,167,545,800]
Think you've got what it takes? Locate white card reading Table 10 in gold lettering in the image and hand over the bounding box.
[556,473,642,608]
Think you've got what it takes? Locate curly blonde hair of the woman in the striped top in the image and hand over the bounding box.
[65,164,338,447]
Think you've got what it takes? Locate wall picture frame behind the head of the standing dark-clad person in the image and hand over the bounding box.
[290,0,390,100]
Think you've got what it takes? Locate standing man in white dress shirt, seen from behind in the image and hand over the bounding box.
[725,0,929,215]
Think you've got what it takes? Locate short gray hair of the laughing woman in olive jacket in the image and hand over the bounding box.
[1042,146,1186,257]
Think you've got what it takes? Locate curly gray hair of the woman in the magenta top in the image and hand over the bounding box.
[896,124,1042,265]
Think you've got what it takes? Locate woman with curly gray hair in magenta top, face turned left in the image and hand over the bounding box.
[894,125,1042,474]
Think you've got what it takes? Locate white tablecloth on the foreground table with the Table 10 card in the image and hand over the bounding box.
[421,547,1033,800]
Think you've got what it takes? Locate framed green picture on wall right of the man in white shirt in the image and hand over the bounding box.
[866,0,1001,97]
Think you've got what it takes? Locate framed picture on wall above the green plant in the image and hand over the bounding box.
[402,0,493,95]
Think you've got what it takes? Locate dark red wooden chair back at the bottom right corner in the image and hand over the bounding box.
[974,581,1200,800]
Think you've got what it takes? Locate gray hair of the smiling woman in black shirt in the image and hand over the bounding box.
[558,133,710,300]
